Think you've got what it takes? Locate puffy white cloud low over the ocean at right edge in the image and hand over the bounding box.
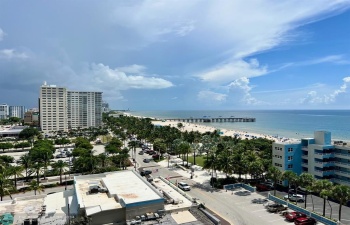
[299,77,350,104]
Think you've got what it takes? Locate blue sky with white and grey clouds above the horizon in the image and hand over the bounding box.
[0,0,350,111]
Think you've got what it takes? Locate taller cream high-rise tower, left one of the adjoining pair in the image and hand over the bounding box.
[40,82,68,132]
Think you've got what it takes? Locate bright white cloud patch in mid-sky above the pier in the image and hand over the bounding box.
[197,59,267,83]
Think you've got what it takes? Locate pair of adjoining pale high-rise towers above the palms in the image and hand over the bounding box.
[39,83,102,132]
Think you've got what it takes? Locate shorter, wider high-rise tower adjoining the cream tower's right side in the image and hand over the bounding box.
[67,91,102,129]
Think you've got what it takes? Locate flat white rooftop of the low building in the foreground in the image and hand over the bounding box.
[75,170,163,212]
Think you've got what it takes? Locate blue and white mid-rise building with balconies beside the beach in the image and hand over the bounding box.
[272,131,350,185]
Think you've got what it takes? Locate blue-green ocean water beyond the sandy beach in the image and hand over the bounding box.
[129,110,350,141]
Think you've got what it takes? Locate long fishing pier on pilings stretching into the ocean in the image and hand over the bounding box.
[163,117,256,123]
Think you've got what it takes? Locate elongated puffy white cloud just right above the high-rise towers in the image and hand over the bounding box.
[90,63,173,90]
